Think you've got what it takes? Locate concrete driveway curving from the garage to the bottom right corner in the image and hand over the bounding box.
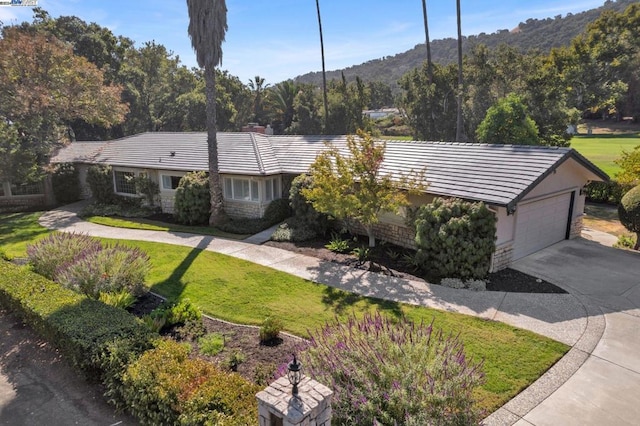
[513,239,640,425]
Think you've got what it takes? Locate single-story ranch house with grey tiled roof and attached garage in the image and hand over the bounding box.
[53,132,608,270]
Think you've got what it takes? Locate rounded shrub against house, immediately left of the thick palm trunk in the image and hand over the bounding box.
[174,172,211,225]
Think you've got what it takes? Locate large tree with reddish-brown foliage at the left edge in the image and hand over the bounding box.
[0,27,127,180]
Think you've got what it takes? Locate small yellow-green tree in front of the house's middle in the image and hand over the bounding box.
[301,131,424,247]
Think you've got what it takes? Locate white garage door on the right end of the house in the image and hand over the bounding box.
[512,192,571,260]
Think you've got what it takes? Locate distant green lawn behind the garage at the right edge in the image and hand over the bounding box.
[571,133,640,178]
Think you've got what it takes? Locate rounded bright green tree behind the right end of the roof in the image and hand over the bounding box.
[476,94,540,145]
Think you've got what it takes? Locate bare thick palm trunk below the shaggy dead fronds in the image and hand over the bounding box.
[204,66,227,226]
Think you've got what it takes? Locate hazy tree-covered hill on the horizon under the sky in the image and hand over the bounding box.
[294,0,635,92]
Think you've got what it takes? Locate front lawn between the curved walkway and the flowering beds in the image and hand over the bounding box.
[0,214,569,412]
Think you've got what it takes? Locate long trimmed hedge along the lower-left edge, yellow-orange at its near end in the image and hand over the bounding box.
[0,260,260,426]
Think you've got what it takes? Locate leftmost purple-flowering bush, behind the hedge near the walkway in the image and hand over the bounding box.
[27,232,102,280]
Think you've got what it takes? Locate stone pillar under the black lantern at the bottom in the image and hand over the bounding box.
[256,376,333,426]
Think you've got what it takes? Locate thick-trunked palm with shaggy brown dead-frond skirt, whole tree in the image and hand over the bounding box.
[187,0,227,225]
